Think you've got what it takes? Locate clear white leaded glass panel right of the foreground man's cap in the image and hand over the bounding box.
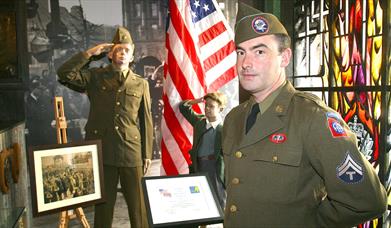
[293,0,329,87]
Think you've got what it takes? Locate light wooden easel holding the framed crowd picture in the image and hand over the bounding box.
[54,97,90,228]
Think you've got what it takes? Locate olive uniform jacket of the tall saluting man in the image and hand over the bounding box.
[57,52,153,167]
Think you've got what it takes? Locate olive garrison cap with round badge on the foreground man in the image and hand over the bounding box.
[235,2,288,44]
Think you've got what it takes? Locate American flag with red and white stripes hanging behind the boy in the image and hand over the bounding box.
[161,0,237,175]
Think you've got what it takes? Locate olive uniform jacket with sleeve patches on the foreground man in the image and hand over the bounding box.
[223,82,387,228]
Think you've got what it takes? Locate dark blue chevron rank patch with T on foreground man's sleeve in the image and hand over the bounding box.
[337,152,364,184]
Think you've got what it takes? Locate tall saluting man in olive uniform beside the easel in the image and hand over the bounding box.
[57,27,153,228]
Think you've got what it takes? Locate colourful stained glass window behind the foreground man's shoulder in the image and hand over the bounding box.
[292,0,391,227]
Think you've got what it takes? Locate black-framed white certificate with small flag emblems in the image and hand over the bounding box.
[142,173,224,227]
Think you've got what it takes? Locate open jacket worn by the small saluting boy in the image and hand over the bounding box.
[179,100,224,183]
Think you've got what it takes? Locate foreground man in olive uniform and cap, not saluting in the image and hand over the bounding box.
[223,3,387,228]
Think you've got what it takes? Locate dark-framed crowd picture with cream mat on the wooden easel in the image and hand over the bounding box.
[29,140,105,217]
